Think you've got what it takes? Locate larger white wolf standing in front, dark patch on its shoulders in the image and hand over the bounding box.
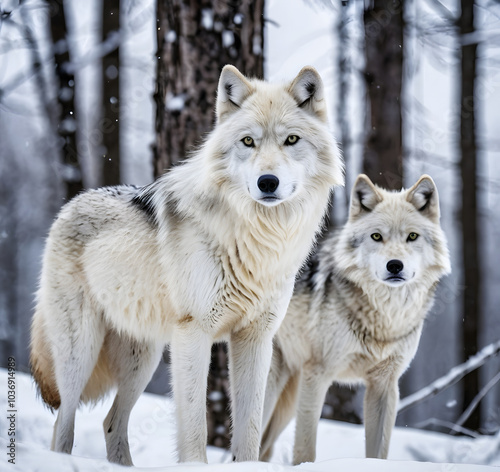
[31,66,343,464]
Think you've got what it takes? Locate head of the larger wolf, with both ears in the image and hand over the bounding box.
[210,66,343,207]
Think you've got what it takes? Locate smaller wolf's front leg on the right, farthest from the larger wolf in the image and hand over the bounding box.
[364,376,399,459]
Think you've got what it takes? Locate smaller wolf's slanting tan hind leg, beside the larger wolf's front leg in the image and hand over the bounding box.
[260,372,300,462]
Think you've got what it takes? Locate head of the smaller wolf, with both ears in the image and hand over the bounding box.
[337,175,450,287]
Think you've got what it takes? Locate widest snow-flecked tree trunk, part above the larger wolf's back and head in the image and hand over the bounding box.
[154,0,264,176]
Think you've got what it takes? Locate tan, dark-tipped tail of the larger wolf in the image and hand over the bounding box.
[30,308,61,410]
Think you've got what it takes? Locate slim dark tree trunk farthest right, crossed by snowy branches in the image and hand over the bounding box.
[459,0,481,430]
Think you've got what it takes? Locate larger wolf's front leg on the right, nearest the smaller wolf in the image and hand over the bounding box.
[229,326,273,461]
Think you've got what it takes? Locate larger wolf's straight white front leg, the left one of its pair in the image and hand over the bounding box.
[170,321,212,462]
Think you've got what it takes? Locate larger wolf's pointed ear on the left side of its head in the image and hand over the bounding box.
[216,65,253,123]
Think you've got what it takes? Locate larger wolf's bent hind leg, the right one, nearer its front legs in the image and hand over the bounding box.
[103,333,163,465]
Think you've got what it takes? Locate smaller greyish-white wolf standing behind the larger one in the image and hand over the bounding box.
[261,175,450,464]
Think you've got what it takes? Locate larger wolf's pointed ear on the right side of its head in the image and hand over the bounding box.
[288,67,327,121]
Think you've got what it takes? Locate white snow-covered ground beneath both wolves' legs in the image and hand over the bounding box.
[0,369,500,472]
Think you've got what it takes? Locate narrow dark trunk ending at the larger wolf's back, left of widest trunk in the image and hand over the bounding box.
[100,0,121,185]
